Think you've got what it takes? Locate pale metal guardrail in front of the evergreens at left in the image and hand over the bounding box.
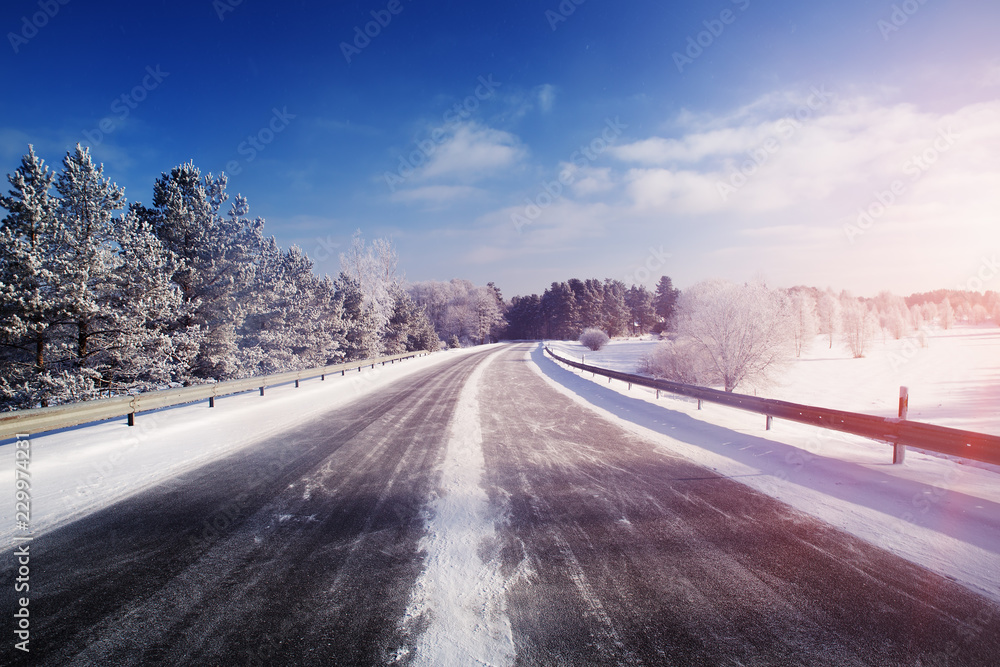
[0,352,429,440]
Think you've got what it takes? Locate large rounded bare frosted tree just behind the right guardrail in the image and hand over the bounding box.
[677,281,794,391]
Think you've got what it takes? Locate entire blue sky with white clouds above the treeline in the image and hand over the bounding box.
[0,0,1000,296]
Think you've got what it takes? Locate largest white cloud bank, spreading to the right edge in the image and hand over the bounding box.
[462,94,1000,294]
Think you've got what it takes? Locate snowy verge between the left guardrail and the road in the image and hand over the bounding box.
[0,347,496,544]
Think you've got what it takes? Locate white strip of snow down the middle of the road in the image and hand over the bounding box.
[397,352,515,667]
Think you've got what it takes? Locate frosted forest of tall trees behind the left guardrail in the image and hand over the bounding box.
[0,145,439,410]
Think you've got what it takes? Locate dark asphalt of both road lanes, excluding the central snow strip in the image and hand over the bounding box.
[0,345,1000,666]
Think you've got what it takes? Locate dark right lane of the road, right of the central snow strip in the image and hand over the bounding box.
[482,346,1000,665]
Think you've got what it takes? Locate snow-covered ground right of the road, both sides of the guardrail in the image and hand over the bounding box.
[532,327,1000,600]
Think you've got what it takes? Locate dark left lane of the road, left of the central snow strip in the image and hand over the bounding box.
[2,349,493,665]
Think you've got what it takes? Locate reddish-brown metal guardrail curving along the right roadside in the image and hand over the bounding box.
[545,346,1000,465]
